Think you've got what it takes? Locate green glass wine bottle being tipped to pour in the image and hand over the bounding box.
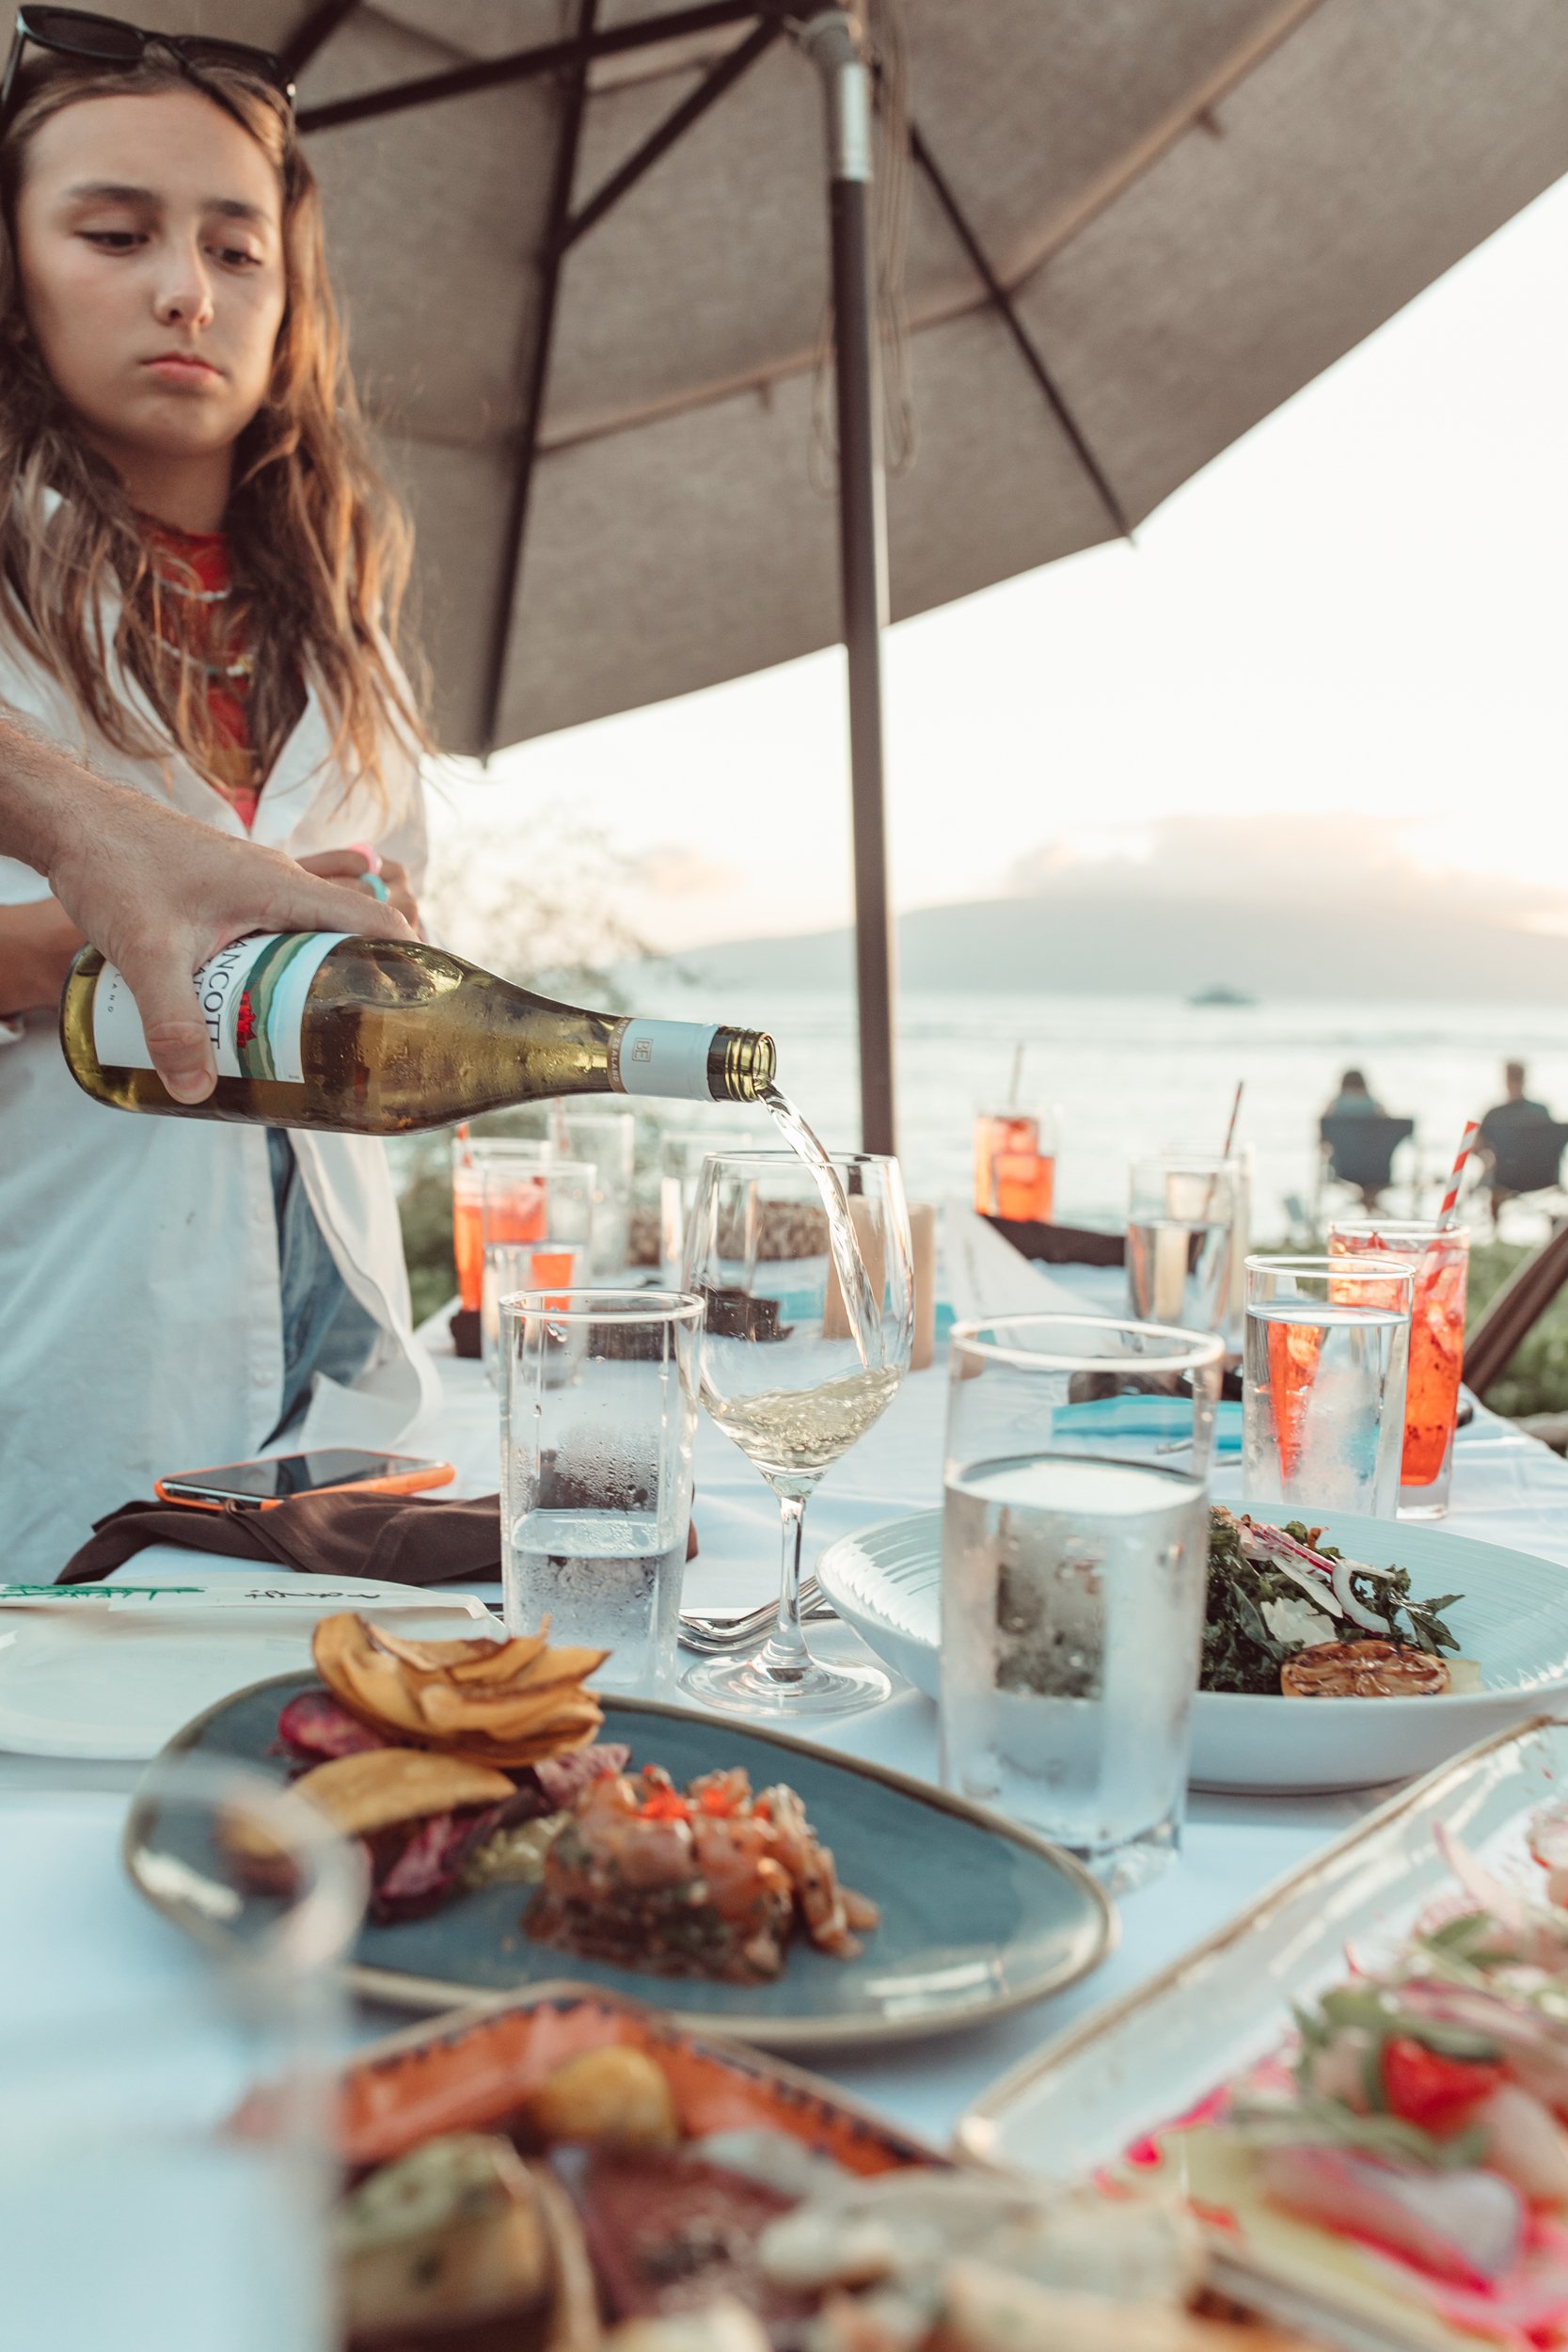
[58,931,773,1136]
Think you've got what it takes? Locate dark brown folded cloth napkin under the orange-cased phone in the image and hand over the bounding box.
[54,1486,696,1585]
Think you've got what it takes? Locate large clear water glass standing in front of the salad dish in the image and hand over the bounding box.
[941,1315,1225,1889]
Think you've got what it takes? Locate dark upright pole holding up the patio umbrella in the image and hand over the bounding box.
[795,8,895,1152]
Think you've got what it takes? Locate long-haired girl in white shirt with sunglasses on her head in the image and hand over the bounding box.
[0,9,435,1579]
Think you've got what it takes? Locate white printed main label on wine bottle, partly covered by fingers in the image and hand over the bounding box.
[91,931,353,1085]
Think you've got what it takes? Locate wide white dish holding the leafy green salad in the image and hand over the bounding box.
[816,1510,1568,1795]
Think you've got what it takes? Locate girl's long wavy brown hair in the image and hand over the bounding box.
[0,50,428,788]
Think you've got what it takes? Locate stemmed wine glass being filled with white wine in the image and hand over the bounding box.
[684,1152,914,1717]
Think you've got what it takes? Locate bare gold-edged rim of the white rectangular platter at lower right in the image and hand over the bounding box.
[955,1720,1568,2352]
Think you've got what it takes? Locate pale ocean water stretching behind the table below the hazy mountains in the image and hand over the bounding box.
[627,972,1568,1242]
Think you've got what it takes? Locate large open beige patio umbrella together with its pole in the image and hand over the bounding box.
[160,0,1568,1148]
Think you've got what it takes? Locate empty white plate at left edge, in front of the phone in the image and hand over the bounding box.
[0,1571,500,1762]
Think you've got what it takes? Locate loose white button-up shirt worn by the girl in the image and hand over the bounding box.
[0,574,437,1583]
